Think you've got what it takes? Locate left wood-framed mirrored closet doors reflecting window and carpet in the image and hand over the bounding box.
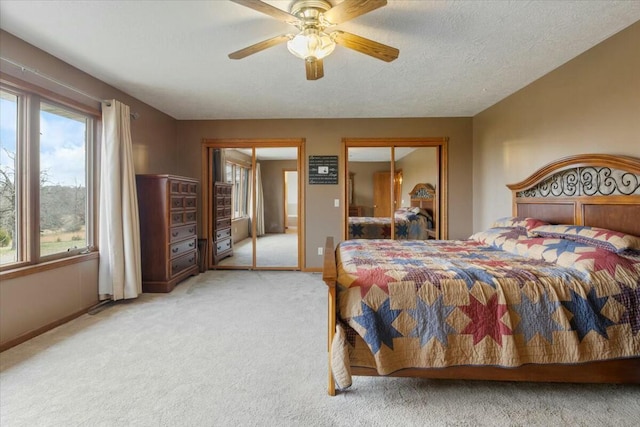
[202,139,304,270]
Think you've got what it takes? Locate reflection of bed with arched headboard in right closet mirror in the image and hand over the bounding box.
[348,183,435,240]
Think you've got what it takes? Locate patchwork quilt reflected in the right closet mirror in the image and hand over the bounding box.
[349,208,433,240]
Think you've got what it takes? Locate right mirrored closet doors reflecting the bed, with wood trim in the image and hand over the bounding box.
[343,138,447,240]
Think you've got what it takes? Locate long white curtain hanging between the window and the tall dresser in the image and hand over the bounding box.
[98,100,142,301]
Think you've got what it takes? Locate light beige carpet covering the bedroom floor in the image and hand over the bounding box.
[0,270,640,427]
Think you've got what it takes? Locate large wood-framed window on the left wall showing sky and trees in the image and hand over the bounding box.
[0,85,95,270]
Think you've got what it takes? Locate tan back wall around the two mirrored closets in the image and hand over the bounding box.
[178,118,472,269]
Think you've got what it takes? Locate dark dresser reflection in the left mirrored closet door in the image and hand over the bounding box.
[211,182,233,265]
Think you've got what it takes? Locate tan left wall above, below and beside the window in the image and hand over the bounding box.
[0,31,177,352]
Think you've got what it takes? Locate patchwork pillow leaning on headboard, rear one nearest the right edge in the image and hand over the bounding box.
[529,225,640,253]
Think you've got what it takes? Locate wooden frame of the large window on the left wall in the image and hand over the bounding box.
[0,76,101,279]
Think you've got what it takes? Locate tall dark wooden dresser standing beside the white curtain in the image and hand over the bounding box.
[136,175,199,292]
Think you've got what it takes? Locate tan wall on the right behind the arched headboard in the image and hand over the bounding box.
[470,22,640,231]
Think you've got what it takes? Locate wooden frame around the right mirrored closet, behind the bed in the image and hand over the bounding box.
[341,137,449,240]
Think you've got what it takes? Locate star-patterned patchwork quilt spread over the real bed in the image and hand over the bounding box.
[332,236,640,388]
